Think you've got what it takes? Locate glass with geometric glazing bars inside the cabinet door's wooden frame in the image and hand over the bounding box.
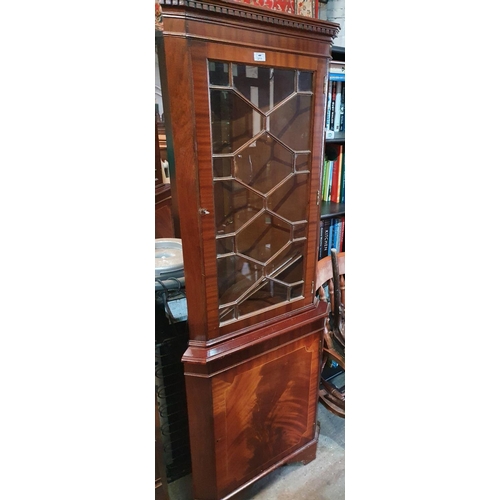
[208,61,314,327]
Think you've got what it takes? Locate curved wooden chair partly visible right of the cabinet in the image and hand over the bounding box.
[316,249,345,418]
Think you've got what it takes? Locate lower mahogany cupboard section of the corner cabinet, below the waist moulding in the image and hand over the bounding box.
[185,325,321,500]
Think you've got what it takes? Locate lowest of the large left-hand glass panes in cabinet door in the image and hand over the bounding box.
[217,255,262,305]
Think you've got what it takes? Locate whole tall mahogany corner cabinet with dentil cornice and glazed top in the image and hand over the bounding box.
[157,0,339,500]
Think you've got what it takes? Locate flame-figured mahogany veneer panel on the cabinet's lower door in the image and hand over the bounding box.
[213,336,319,493]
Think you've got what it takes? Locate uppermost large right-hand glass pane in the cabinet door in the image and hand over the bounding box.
[270,94,312,151]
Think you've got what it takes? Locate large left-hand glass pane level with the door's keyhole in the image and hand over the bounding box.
[214,181,264,235]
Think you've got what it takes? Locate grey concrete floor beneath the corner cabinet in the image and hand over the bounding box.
[169,404,345,500]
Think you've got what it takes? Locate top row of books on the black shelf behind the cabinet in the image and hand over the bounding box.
[325,64,345,139]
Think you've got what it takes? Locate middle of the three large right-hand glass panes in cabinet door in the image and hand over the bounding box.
[267,174,309,222]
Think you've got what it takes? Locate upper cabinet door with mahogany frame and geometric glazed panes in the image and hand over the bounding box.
[163,40,326,342]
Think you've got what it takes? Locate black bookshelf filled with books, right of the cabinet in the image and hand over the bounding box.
[318,47,345,260]
